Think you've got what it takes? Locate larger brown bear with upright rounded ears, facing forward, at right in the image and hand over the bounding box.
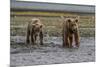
[63,17,80,48]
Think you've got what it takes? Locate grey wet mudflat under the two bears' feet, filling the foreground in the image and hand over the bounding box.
[10,36,95,66]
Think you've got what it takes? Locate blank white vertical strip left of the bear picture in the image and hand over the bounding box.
[0,0,10,67]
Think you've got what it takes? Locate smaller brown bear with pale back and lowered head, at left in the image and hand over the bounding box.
[26,18,43,45]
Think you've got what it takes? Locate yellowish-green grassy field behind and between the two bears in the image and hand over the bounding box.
[10,12,95,37]
